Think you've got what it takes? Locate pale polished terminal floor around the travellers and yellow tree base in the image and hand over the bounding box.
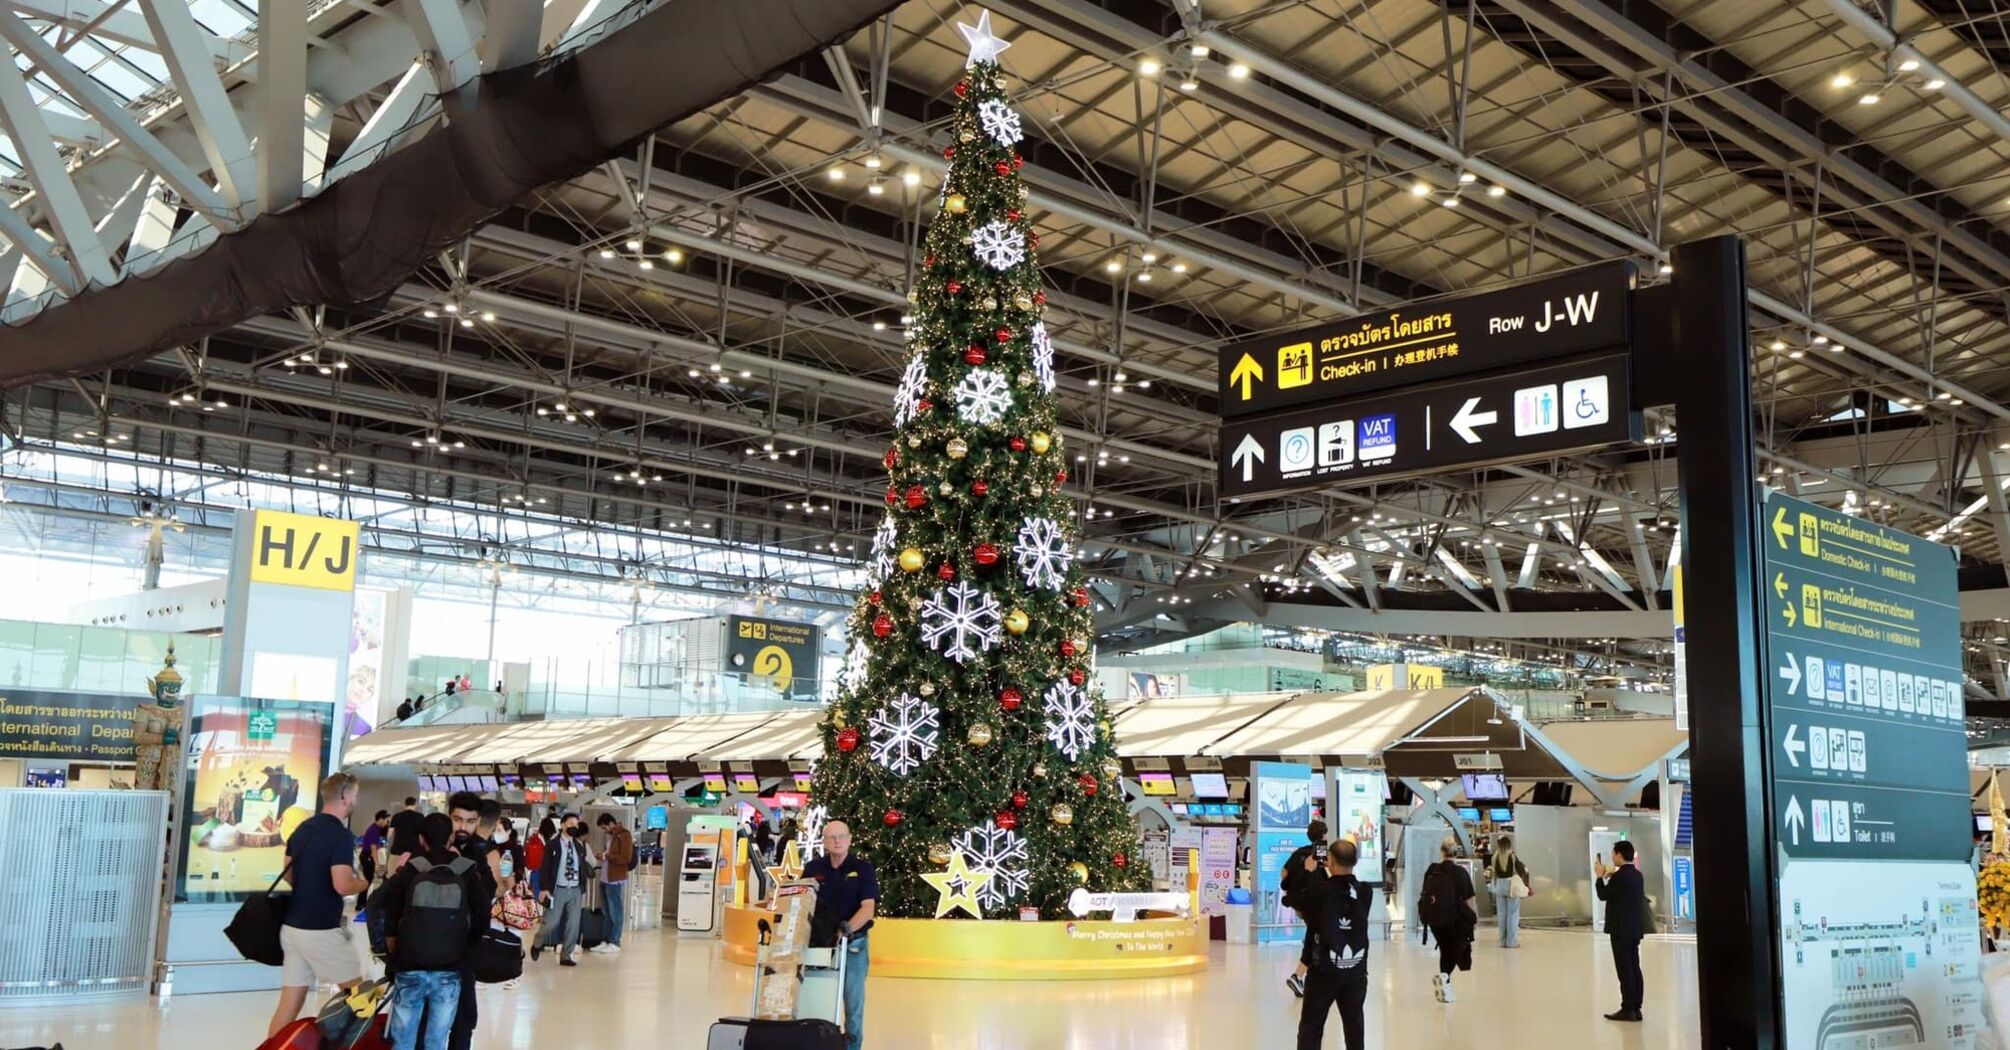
[0,929,1700,1050]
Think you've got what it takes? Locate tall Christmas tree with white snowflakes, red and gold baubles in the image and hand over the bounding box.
[804,14,1144,917]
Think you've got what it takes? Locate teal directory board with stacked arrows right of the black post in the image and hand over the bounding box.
[1765,493,1972,861]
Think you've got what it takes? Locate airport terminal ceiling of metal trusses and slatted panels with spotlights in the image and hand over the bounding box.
[0,0,2010,698]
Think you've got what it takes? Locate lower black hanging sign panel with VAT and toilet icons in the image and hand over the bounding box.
[1220,354,1640,497]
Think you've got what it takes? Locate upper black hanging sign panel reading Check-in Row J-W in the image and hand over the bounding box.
[1220,261,1634,418]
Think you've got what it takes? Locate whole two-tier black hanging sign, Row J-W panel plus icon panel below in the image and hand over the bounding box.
[1220,261,1640,499]
